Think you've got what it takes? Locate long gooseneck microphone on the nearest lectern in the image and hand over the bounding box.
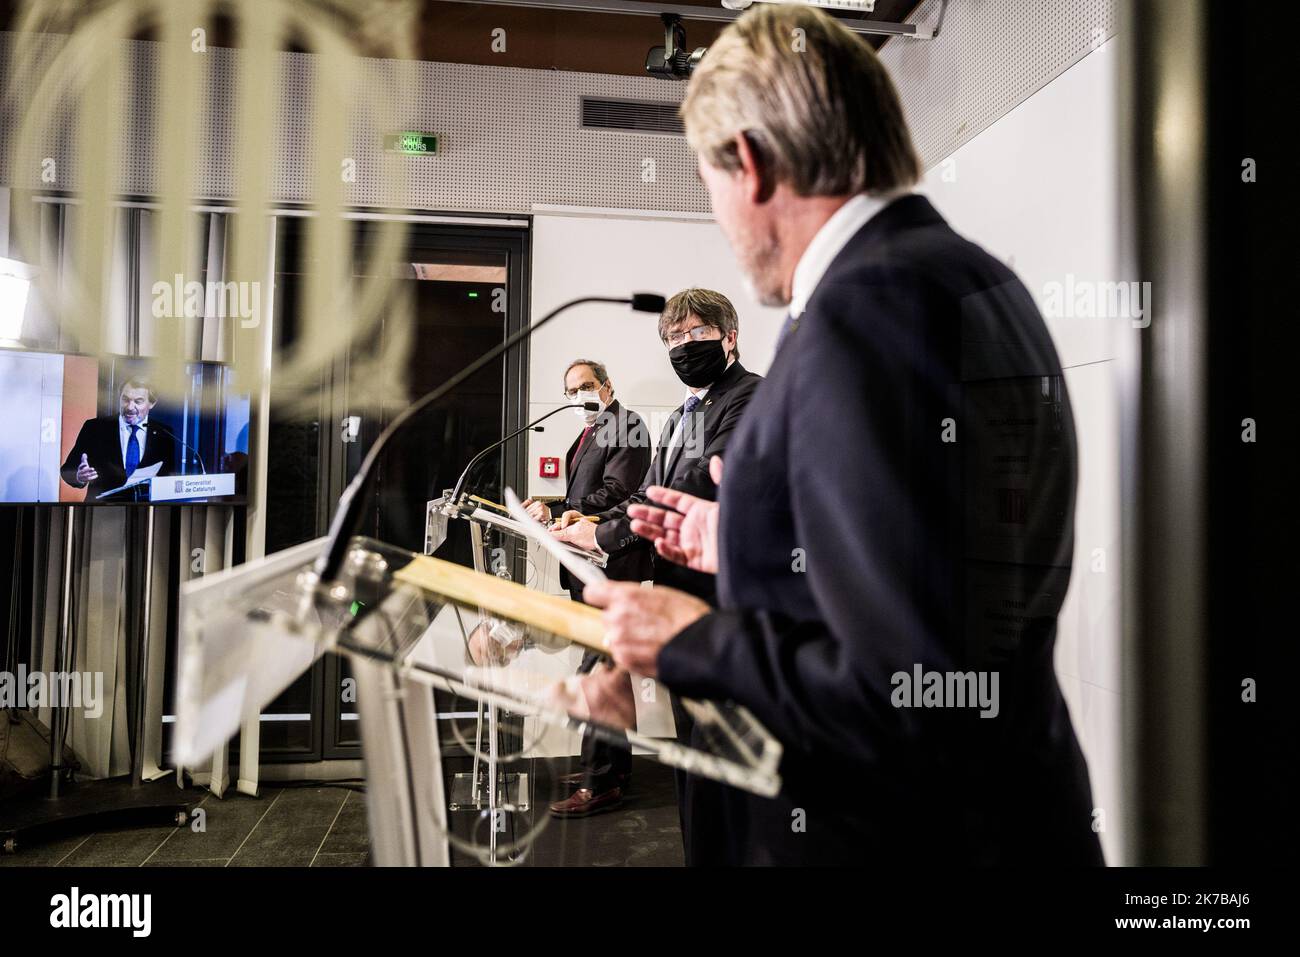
[316,293,667,584]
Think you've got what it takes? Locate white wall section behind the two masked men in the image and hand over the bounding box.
[528,209,785,495]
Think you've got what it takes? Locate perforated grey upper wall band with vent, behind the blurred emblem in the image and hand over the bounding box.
[0,34,709,213]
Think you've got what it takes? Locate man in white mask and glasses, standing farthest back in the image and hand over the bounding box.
[524,359,653,818]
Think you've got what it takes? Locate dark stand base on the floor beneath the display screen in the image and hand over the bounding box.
[0,776,194,854]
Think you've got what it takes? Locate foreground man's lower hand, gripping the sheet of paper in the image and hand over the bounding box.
[582,581,711,677]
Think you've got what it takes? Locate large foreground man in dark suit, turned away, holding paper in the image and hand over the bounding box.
[588,7,1101,866]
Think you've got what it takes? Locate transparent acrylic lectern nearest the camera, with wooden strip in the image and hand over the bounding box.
[176,538,781,866]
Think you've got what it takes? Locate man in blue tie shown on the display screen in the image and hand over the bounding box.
[59,377,177,502]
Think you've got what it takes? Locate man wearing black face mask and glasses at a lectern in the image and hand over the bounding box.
[559,289,762,862]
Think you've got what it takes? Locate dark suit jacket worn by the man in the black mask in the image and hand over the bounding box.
[595,361,763,603]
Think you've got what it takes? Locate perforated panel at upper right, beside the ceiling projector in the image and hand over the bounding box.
[880,0,1115,166]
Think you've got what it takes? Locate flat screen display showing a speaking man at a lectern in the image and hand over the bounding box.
[0,350,250,506]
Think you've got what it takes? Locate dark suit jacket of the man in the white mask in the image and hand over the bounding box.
[550,399,653,590]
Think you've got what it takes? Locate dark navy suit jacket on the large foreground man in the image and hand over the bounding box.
[659,196,1101,866]
